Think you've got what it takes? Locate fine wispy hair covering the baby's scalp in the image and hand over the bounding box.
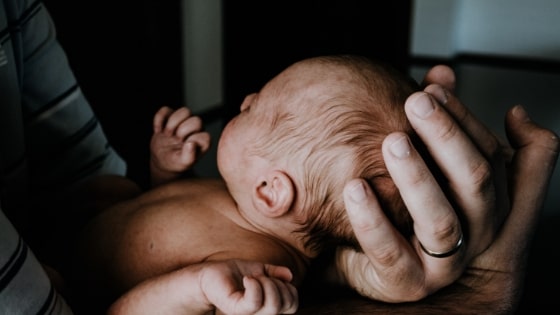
[255,55,434,250]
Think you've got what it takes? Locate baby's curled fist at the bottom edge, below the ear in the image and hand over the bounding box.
[200,260,299,315]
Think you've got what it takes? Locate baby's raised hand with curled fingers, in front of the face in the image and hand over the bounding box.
[150,107,210,185]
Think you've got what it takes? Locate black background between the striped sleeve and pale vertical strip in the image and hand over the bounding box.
[44,0,183,186]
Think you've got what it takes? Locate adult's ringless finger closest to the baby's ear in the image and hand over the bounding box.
[342,179,425,302]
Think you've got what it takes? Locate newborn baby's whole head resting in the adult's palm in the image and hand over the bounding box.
[218,56,426,254]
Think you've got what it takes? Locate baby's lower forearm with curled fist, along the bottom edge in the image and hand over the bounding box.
[108,260,298,315]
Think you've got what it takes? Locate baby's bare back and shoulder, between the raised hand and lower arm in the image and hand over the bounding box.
[77,180,302,291]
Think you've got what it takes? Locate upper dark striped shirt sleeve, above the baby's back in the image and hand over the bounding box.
[20,3,126,190]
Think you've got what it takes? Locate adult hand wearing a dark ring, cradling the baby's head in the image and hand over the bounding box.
[337,67,559,304]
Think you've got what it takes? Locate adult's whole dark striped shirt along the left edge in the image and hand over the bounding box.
[0,0,126,314]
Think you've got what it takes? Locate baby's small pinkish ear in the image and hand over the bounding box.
[253,170,295,218]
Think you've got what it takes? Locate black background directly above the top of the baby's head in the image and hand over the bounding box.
[223,0,411,122]
